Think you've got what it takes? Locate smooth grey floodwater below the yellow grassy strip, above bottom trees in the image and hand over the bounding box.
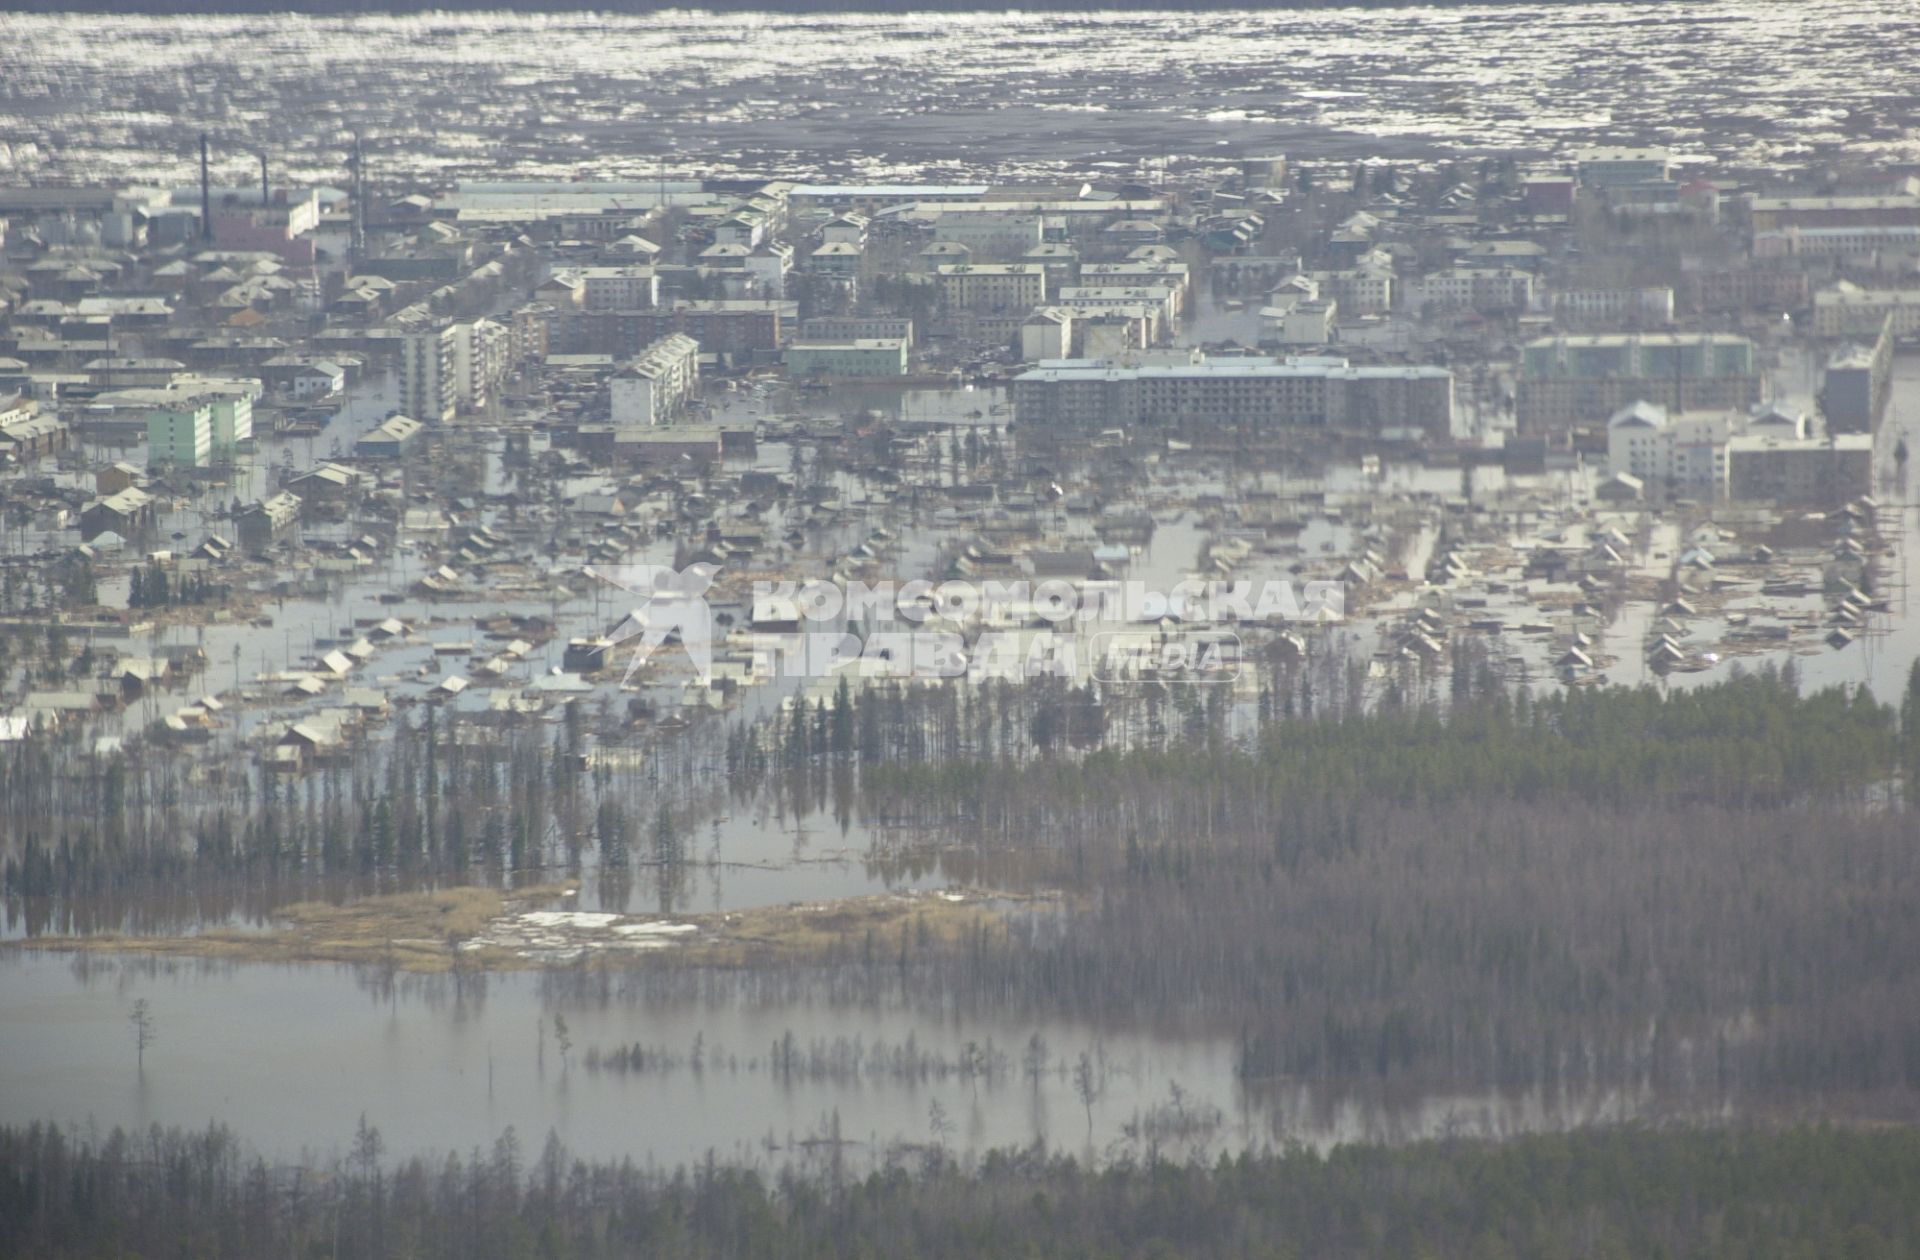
[0,953,1681,1170]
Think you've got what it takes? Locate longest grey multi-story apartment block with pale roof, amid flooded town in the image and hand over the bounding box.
[1014,351,1453,436]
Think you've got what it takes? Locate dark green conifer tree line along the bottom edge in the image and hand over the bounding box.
[0,1120,1920,1260]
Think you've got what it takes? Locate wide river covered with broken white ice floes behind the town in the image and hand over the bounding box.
[0,0,1920,186]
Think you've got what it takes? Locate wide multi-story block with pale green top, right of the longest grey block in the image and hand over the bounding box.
[1517,332,1763,434]
